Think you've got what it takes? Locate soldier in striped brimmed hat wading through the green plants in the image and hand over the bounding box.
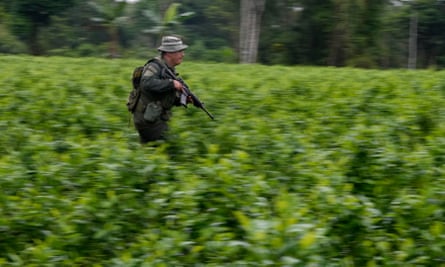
[133,36,188,144]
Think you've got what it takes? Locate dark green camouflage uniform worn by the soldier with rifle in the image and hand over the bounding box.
[133,57,180,143]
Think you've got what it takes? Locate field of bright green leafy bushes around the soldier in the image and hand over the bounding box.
[0,56,445,267]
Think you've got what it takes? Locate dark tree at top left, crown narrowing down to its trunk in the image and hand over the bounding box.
[11,0,73,55]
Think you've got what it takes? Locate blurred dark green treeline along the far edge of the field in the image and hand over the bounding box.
[0,0,445,68]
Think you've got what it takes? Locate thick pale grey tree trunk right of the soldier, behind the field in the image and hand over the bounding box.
[239,0,266,63]
